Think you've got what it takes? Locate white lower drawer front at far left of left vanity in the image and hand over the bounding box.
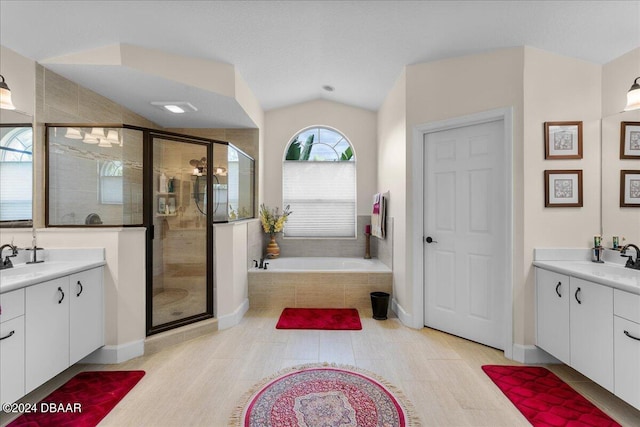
[0,316,25,403]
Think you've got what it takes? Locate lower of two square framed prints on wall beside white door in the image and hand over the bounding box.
[544,169,582,208]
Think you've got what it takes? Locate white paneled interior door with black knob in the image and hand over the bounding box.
[424,120,510,349]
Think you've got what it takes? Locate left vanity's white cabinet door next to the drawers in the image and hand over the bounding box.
[25,276,70,393]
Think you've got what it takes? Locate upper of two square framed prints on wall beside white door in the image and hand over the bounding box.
[544,121,582,160]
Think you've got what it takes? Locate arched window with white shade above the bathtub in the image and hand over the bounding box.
[282,127,356,238]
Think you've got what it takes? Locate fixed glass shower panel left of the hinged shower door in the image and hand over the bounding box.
[46,125,144,227]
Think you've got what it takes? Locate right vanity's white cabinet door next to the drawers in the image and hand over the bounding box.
[570,277,613,392]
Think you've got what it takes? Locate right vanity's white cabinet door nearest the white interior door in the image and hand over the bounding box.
[536,268,571,364]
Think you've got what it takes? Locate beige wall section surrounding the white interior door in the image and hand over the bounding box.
[404,48,525,332]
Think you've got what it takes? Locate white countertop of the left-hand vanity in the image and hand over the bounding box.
[0,248,106,294]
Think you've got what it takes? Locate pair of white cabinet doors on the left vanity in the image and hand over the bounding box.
[25,267,104,393]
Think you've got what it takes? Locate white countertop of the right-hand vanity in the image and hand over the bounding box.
[533,260,640,295]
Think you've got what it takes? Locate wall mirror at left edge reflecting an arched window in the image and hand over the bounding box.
[0,110,33,227]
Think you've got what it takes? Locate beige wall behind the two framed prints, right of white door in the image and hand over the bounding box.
[514,48,602,344]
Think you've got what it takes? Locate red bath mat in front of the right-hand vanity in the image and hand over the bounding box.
[482,365,620,427]
